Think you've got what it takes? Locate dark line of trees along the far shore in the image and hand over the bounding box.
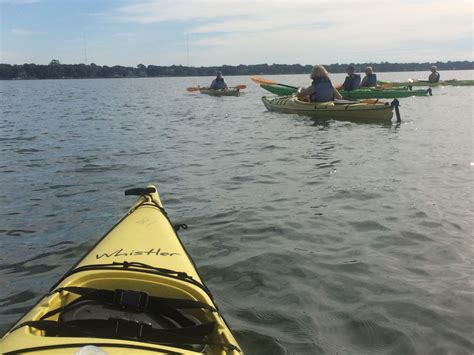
[0,59,474,80]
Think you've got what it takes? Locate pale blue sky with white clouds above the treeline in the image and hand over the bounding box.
[0,0,474,66]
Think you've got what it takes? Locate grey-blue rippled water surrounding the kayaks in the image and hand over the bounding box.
[0,71,474,354]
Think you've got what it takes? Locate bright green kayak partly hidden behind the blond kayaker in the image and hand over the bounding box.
[260,84,431,99]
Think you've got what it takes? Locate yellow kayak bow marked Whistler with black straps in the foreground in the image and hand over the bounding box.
[0,185,242,355]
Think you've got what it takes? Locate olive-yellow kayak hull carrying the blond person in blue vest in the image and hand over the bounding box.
[262,96,393,123]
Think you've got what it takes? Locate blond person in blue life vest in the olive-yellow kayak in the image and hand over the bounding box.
[297,65,342,102]
